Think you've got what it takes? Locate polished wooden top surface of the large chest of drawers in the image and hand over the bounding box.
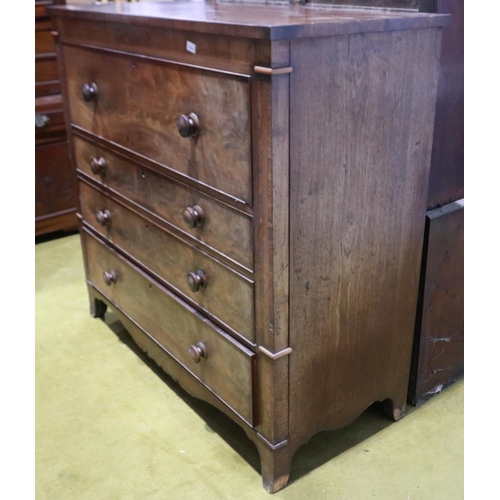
[50,0,449,40]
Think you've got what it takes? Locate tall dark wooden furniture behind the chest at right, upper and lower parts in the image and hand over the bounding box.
[408,0,464,405]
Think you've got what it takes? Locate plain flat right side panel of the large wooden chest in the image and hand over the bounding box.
[290,30,440,439]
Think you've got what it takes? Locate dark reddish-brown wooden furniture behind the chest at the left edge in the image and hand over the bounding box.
[35,0,78,236]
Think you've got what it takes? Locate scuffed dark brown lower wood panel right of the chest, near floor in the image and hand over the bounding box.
[409,200,464,405]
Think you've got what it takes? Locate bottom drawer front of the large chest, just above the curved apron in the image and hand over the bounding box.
[82,231,255,424]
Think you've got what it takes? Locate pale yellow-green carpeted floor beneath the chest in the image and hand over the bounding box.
[36,235,464,500]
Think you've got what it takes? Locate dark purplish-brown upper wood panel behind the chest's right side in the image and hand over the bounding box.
[427,0,464,210]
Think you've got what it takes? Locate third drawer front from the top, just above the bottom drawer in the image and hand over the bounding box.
[80,182,254,342]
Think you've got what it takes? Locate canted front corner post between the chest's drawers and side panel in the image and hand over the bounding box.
[252,41,290,448]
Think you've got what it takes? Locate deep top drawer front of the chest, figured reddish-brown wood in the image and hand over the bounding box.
[64,46,252,203]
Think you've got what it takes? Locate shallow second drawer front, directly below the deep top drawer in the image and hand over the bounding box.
[74,136,253,270]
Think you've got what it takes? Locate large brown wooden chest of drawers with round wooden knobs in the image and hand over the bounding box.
[51,2,447,492]
